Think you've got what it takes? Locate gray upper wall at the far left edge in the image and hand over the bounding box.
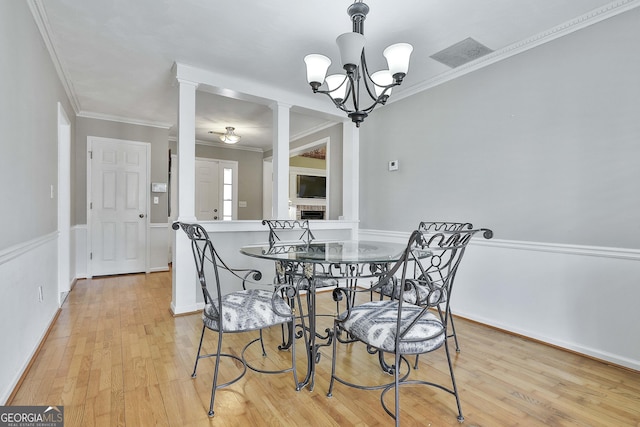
[0,1,74,250]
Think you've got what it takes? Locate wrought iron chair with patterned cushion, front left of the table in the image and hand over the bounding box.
[172,222,298,417]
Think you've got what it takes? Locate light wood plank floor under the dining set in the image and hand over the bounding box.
[11,273,640,427]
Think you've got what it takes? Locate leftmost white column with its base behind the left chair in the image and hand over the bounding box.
[171,79,199,314]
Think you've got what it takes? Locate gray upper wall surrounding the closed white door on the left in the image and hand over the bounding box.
[71,117,169,224]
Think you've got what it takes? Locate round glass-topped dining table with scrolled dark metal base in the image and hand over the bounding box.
[240,240,426,390]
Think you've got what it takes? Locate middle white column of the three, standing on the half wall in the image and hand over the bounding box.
[271,102,291,219]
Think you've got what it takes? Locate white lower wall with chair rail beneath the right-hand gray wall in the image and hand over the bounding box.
[359,229,640,371]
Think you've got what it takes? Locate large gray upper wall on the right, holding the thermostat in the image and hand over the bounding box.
[360,9,640,248]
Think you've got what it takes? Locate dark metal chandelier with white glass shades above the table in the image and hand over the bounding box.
[304,0,413,127]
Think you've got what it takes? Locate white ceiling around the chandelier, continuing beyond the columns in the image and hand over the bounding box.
[30,0,640,149]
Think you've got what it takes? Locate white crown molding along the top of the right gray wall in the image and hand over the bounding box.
[387,0,640,104]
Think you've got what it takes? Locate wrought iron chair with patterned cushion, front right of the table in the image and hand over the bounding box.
[327,230,474,426]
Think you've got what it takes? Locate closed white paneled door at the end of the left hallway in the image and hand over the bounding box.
[88,137,149,276]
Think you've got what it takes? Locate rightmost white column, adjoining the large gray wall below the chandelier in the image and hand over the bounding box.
[342,122,360,233]
